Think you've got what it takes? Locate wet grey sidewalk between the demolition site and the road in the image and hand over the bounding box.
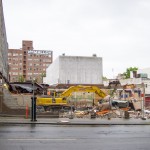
[0,117,150,125]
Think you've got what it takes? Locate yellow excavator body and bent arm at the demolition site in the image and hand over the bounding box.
[36,85,106,106]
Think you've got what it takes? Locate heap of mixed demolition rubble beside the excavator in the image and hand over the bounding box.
[57,100,150,119]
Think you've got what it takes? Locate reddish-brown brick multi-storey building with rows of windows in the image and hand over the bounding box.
[8,40,53,83]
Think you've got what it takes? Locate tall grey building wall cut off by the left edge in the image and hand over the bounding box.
[0,0,8,79]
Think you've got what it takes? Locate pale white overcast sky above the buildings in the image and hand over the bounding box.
[3,0,150,78]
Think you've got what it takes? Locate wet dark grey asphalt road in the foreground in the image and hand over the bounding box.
[0,125,150,150]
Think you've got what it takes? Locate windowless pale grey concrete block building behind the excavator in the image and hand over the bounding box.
[46,56,103,84]
